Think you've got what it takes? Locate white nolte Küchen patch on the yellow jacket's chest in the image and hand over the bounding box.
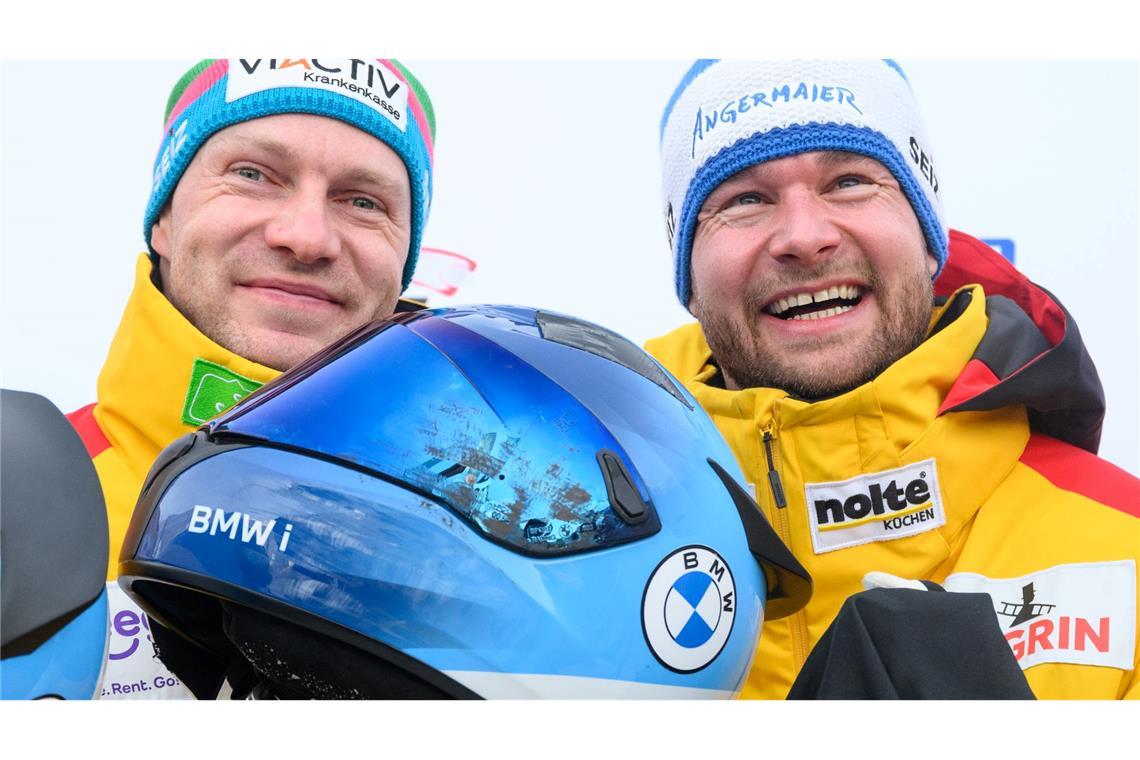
[805,459,946,554]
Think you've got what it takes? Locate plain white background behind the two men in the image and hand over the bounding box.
[0,59,1140,474]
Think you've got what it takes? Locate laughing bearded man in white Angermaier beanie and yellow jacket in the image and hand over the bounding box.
[646,60,1140,698]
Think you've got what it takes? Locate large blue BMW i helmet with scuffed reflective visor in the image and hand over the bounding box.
[119,307,811,698]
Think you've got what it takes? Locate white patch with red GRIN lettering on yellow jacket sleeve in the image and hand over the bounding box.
[943,559,1137,670]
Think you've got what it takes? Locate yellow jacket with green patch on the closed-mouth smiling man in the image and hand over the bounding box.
[68,254,278,580]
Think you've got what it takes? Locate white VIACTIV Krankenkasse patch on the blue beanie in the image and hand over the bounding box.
[226,58,408,132]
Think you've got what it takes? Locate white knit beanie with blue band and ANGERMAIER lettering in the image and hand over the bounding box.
[661,60,947,308]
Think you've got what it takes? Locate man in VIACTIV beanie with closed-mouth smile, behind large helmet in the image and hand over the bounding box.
[60,58,435,698]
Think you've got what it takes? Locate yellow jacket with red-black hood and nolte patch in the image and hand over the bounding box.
[645,232,1140,698]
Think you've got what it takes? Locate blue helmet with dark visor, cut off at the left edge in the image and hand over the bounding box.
[0,390,108,700]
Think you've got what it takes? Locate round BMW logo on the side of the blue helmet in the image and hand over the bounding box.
[642,546,736,673]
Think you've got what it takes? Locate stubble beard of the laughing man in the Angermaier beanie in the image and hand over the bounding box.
[693,263,934,401]
